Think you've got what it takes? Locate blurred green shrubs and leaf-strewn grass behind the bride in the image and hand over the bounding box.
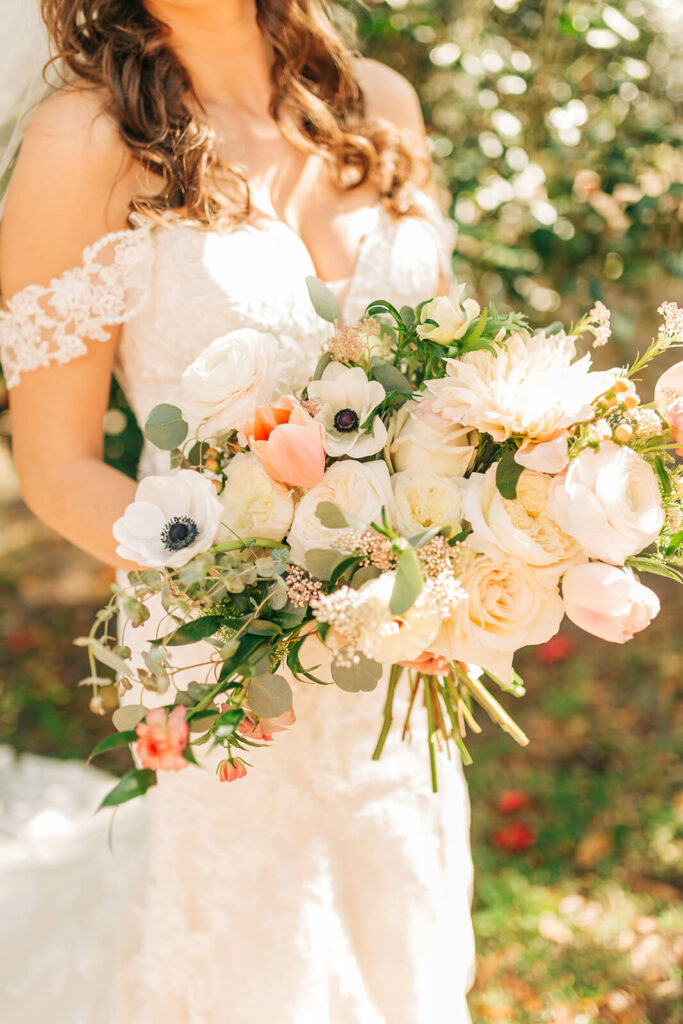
[0,0,683,1024]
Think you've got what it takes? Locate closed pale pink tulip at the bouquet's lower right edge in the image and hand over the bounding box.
[562,562,659,643]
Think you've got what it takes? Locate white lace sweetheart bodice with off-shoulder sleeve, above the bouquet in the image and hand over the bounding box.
[0,191,452,471]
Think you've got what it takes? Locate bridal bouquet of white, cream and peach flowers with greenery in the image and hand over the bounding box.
[82,279,683,805]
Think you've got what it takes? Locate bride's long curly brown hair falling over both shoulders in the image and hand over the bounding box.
[42,0,419,227]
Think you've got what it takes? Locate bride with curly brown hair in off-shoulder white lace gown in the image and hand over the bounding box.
[0,0,474,1024]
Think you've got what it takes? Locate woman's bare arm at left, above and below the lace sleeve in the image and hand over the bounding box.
[0,92,147,568]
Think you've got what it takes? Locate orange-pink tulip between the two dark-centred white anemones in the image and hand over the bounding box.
[242,395,325,487]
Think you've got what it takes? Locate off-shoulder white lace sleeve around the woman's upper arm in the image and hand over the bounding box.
[0,218,152,387]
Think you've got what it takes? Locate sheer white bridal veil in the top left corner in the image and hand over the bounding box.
[0,0,58,215]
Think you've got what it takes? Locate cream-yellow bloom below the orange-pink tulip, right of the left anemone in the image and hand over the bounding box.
[218,453,294,541]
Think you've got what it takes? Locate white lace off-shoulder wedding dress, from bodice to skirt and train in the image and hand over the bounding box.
[0,194,474,1024]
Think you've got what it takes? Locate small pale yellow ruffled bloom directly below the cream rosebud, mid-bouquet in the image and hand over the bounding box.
[391,469,463,538]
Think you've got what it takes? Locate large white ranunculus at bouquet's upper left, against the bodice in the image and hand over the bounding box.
[180,328,281,438]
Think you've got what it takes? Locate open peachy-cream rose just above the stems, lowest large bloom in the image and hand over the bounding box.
[431,535,563,682]
